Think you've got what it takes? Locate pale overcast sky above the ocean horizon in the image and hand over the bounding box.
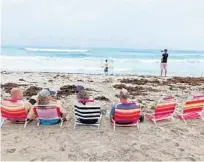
[1,0,204,50]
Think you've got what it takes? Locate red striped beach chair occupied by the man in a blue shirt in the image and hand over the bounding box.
[112,102,141,130]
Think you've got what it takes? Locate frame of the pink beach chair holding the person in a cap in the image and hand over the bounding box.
[33,105,64,127]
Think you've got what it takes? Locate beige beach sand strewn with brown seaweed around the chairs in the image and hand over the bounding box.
[1,72,204,161]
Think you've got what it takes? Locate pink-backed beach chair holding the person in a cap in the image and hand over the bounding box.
[33,105,63,127]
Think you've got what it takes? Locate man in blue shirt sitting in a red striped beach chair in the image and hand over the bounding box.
[110,88,144,122]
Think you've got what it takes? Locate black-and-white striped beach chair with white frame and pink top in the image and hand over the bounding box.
[74,100,102,129]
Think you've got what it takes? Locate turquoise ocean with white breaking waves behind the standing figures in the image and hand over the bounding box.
[0,47,204,76]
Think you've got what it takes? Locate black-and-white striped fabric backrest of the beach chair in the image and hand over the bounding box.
[74,104,101,120]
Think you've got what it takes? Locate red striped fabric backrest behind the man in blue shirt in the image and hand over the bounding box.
[114,108,140,124]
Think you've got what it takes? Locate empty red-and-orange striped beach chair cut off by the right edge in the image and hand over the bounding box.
[177,95,204,124]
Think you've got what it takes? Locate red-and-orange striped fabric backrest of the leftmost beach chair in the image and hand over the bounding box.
[1,105,27,121]
